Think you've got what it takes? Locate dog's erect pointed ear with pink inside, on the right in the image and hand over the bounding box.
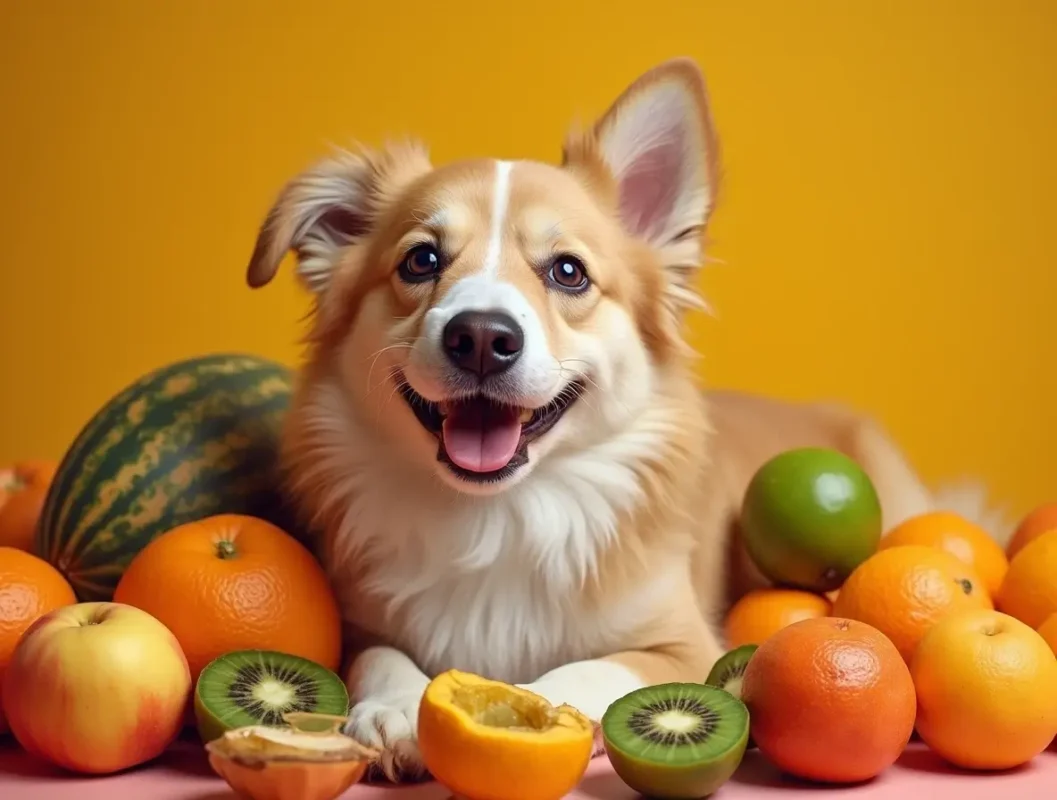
[564,58,719,306]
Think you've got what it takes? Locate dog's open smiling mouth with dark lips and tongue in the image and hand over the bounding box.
[400,378,583,483]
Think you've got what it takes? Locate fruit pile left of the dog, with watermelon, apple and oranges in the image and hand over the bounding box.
[0,355,371,797]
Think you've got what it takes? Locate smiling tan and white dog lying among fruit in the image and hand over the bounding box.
[246,58,1006,781]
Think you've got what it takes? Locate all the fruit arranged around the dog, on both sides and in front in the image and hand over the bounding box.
[0,355,1057,800]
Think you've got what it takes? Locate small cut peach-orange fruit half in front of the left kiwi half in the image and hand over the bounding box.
[205,712,379,800]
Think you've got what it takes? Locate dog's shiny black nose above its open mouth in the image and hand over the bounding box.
[444,311,524,377]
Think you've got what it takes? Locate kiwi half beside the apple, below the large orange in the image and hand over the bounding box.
[194,650,349,742]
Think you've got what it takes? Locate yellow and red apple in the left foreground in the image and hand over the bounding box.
[2,602,191,774]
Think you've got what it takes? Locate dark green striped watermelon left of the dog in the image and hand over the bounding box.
[34,354,294,601]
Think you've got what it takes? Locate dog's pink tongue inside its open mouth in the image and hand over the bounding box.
[444,401,521,472]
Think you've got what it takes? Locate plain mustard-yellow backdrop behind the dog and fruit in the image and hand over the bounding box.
[0,0,1057,522]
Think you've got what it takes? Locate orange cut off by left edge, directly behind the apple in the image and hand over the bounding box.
[0,547,77,732]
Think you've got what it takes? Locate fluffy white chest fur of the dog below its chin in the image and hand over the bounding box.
[325,414,668,683]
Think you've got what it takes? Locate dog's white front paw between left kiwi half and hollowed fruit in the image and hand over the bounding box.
[345,694,429,783]
